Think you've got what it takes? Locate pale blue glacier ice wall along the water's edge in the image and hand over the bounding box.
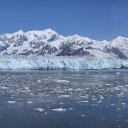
[0,55,128,70]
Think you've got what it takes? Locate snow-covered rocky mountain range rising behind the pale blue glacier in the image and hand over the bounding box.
[0,29,128,59]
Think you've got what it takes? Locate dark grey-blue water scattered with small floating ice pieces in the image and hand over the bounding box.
[0,70,128,128]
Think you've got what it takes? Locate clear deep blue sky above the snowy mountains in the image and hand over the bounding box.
[0,0,128,40]
